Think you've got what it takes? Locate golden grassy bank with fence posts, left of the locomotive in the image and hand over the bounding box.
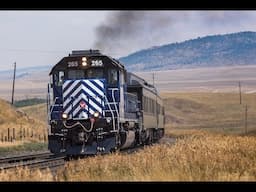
[0,100,47,147]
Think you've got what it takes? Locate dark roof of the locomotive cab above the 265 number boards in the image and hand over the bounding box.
[49,49,125,75]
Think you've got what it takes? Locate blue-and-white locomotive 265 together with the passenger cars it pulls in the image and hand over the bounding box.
[47,50,164,156]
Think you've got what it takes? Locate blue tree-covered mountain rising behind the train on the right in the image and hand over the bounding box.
[120,31,256,71]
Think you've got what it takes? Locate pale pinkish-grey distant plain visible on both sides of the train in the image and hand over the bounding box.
[0,65,256,101]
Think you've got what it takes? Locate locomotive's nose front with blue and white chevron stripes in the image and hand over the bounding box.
[63,79,105,120]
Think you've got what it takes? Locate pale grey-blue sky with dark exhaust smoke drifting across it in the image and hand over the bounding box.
[0,11,256,71]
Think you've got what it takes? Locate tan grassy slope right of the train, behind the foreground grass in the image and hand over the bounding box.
[162,93,256,134]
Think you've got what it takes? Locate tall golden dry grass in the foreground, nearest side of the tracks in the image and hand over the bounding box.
[0,130,256,181]
